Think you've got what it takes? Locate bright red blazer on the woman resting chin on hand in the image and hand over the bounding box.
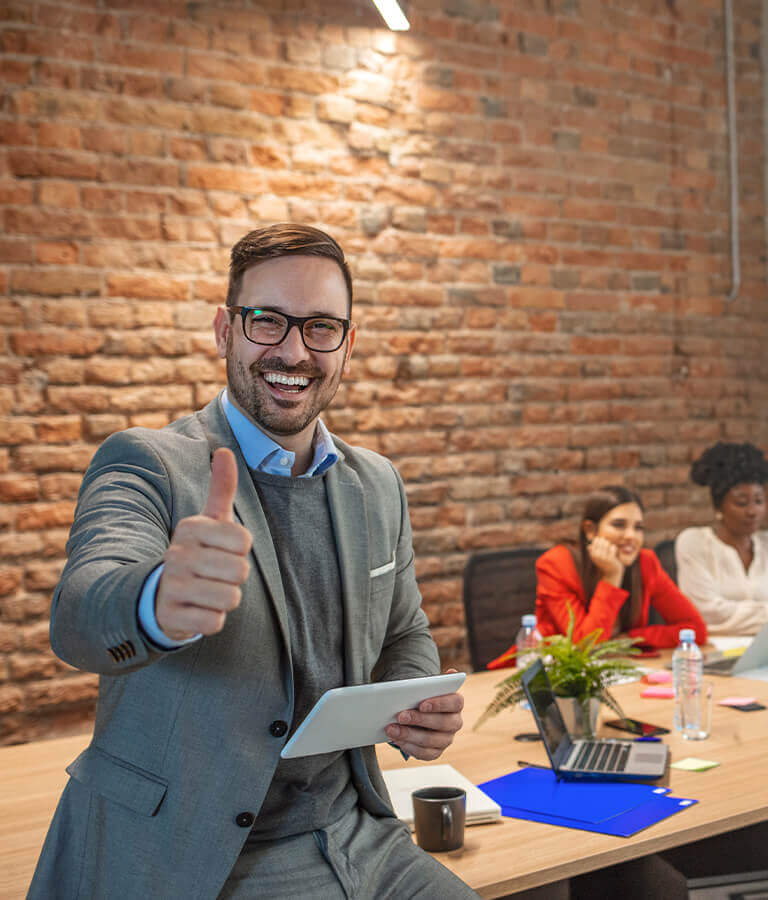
[536,545,707,648]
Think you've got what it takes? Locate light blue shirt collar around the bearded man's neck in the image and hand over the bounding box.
[221,388,339,478]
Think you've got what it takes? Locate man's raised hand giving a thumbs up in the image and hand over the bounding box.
[155,447,251,641]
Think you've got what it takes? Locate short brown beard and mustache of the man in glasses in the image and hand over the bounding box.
[227,348,343,435]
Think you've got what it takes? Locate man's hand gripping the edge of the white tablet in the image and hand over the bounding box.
[385,669,464,760]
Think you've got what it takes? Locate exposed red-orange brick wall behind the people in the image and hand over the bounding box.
[0,0,768,743]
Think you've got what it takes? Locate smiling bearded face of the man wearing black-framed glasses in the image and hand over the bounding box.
[214,256,355,455]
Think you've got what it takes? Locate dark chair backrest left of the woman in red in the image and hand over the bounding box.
[464,547,544,671]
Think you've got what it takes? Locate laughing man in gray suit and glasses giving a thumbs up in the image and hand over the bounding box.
[29,225,477,900]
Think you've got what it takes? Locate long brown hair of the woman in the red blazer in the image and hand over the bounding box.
[571,484,643,637]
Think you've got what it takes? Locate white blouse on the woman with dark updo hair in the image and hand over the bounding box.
[675,525,768,634]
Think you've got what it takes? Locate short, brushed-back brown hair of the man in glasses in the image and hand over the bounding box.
[227,222,352,316]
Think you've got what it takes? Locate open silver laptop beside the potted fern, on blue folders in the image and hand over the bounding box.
[520,659,669,781]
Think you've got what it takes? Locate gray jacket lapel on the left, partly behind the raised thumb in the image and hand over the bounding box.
[200,397,291,659]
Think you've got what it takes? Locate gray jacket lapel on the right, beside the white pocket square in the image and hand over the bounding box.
[326,454,370,684]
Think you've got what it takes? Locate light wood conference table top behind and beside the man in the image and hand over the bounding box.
[0,672,768,900]
